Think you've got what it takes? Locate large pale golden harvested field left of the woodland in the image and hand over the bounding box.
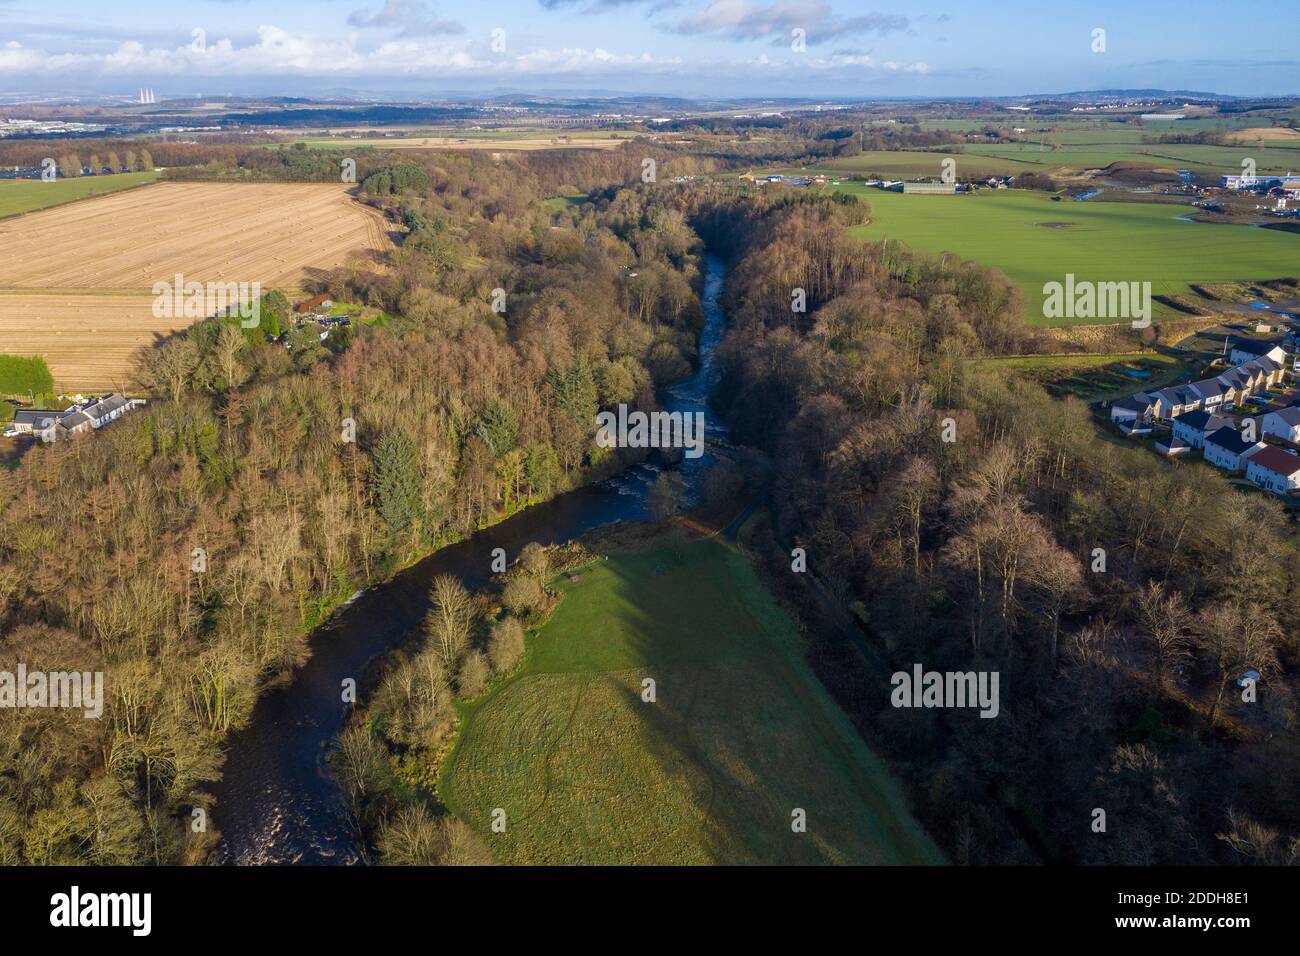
[0,182,389,390]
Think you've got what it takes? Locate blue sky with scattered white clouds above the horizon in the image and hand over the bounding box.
[0,0,1300,101]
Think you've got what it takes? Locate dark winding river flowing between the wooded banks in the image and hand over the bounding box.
[212,255,725,864]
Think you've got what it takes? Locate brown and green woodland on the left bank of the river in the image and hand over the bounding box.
[0,145,702,864]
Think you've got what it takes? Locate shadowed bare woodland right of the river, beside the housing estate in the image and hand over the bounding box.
[698,183,1300,864]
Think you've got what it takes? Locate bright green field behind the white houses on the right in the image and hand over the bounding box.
[837,183,1300,324]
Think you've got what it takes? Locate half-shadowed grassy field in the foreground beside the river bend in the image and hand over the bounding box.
[439,540,943,864]
